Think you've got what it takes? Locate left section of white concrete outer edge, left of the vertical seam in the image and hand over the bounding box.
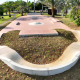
[1,57,48,76]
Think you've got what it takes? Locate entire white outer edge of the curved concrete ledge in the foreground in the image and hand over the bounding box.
[0,52,80,76]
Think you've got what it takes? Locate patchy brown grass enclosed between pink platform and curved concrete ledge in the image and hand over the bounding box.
[0,30,76,64]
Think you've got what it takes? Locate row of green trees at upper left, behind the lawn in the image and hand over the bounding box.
[0,0,42,17]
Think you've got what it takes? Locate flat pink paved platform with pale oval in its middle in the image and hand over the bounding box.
[0,14,71,36]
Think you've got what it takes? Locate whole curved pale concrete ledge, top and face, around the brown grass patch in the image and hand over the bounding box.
[0,30,80,76]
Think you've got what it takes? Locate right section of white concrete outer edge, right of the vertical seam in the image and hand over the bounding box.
[49,53,79,75]
